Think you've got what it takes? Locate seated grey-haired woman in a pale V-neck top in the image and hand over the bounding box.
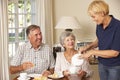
[55,32,92,80]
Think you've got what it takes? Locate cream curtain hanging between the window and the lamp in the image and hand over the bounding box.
[36,0,53,47]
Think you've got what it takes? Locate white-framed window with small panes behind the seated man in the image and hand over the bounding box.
[8,0,36,57]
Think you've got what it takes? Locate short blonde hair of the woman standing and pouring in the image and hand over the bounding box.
[88,0,109,15]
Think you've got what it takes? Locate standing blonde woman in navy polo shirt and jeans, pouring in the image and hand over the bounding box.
[80,0,120,80]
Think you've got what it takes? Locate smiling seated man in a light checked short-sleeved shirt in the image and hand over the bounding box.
[10,25,55,75]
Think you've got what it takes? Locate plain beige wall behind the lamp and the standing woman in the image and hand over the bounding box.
[53,0,120,43]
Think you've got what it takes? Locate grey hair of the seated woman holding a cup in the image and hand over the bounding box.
[60,31,75,46]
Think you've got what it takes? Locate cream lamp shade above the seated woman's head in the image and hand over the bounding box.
[55,16,81,30]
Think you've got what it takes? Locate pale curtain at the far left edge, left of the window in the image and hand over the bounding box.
[0,0,9,80]
